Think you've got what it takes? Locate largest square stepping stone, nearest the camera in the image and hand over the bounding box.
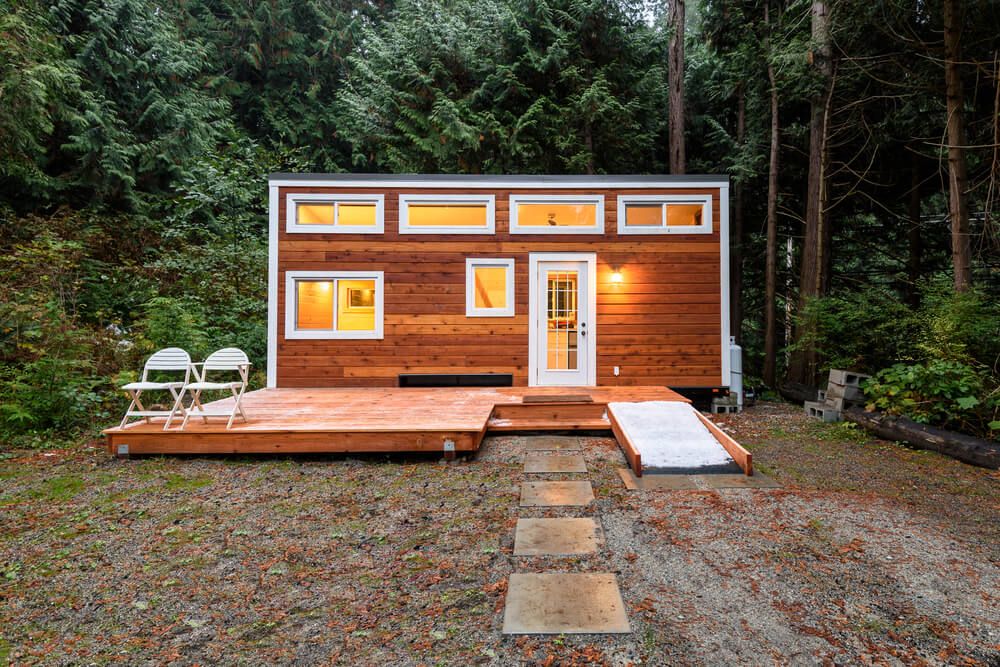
[503,572,632,635]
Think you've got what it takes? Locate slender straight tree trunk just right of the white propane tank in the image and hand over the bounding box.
[764,28,781,387]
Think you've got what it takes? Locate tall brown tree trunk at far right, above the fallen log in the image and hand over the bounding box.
[944,0,972,291]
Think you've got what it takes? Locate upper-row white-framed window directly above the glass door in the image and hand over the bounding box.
[510,195,604,234]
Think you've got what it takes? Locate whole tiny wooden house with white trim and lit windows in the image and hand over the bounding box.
[267,174,730,389]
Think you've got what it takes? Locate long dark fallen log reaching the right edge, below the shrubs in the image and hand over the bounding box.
[843,408,1000,470]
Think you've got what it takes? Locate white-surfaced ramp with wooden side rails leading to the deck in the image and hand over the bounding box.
[608,401,752,475]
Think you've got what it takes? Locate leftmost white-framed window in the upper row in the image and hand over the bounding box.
[285,192,385,234]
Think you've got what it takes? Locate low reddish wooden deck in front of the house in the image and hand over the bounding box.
[104,387,687,455]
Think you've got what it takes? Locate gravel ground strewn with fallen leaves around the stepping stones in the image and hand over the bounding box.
[0,404,1000,665]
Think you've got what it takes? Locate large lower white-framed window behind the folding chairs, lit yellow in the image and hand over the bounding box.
[285,271,384,340]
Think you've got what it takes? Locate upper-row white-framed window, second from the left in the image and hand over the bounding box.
[399,194,496,234]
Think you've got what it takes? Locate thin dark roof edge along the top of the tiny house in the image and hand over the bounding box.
[267,172,729,184]
